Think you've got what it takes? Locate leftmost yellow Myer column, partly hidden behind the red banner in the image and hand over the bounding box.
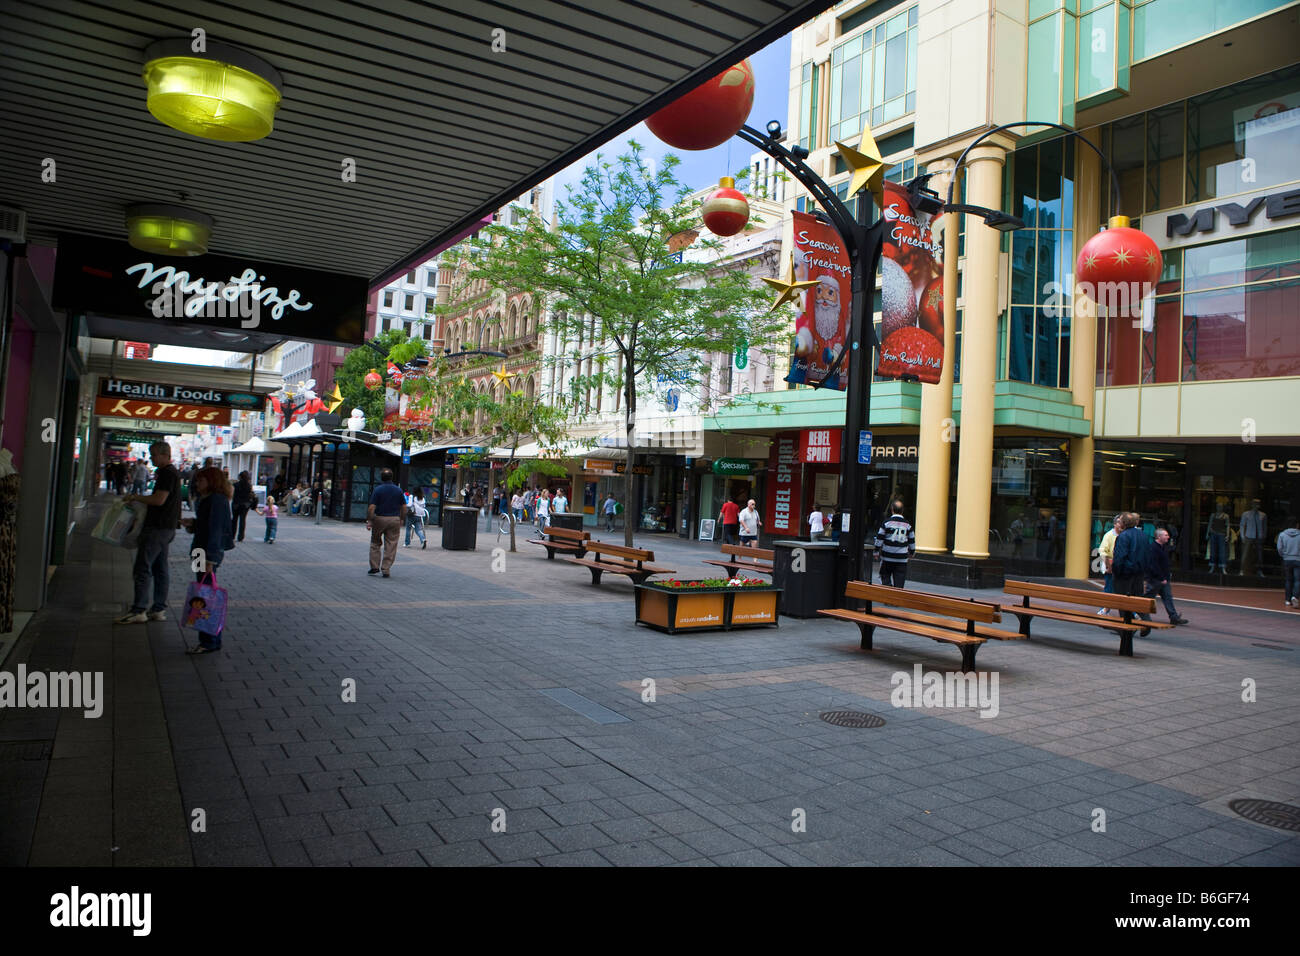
[917,160,958,554]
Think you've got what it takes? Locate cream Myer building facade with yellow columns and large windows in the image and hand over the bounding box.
[719,0,1300,583]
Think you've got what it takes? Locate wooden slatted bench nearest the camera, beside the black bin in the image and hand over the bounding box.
[818,581,1021,671]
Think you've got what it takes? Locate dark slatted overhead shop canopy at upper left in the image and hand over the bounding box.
[0,0,831,332]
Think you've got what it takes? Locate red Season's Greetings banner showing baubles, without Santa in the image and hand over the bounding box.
[876,182,944,385]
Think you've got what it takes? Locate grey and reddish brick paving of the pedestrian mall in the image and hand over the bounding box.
[0,516,1300,866]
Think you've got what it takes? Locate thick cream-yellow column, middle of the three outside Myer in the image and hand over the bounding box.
[953,143,1006,558]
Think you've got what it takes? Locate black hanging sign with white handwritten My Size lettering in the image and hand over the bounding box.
[53,235,368,346]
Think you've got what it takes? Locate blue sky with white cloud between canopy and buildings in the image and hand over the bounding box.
[153,36,790,365]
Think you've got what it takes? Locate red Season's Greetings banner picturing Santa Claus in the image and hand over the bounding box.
[785,212,853,390]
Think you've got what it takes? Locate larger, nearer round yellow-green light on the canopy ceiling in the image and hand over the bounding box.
[143,39,282,143]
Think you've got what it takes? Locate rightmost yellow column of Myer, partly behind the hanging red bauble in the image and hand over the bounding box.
[1065,133,1101,579]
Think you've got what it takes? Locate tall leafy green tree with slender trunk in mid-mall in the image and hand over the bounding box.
[467,142,789,545]
